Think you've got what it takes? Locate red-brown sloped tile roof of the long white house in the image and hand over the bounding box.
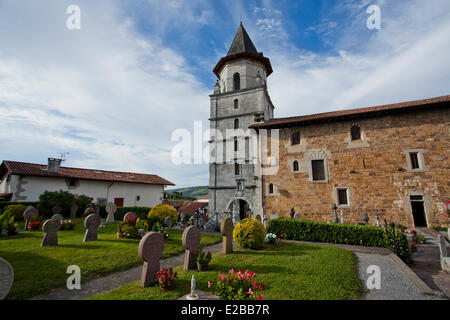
[0,160,175,186]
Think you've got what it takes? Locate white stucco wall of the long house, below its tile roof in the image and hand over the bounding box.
[7,175,164,207]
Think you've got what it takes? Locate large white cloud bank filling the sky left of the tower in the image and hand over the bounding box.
[0,1,210,184]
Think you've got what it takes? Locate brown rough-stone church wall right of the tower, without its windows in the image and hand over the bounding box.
[264,108,450,227]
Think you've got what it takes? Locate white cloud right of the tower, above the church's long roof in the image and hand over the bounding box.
[258,0,450,117]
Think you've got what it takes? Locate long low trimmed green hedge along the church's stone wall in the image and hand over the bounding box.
[267,218,411,263]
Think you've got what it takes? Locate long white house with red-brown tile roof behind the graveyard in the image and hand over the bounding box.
[0,158,174,207]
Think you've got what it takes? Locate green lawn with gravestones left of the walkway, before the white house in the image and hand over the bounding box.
[0,218,222,300]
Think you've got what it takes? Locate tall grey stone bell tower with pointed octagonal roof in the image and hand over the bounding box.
[208,22,274,223]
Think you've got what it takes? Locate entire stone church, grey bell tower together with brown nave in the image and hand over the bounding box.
[209,23,450,227]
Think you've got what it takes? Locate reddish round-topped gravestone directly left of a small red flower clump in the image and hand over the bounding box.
[138,232,164,288]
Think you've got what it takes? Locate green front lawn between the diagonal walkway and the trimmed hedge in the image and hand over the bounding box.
[89,243,363,300]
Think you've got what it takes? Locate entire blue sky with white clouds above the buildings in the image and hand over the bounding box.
[0,0,450,187]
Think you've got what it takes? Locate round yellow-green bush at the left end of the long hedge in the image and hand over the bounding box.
[233,218,266,249]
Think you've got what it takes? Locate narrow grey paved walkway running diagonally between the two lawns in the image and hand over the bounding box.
[31,242,222,300]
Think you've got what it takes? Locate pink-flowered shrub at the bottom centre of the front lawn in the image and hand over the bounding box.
[208,269,265,300]
